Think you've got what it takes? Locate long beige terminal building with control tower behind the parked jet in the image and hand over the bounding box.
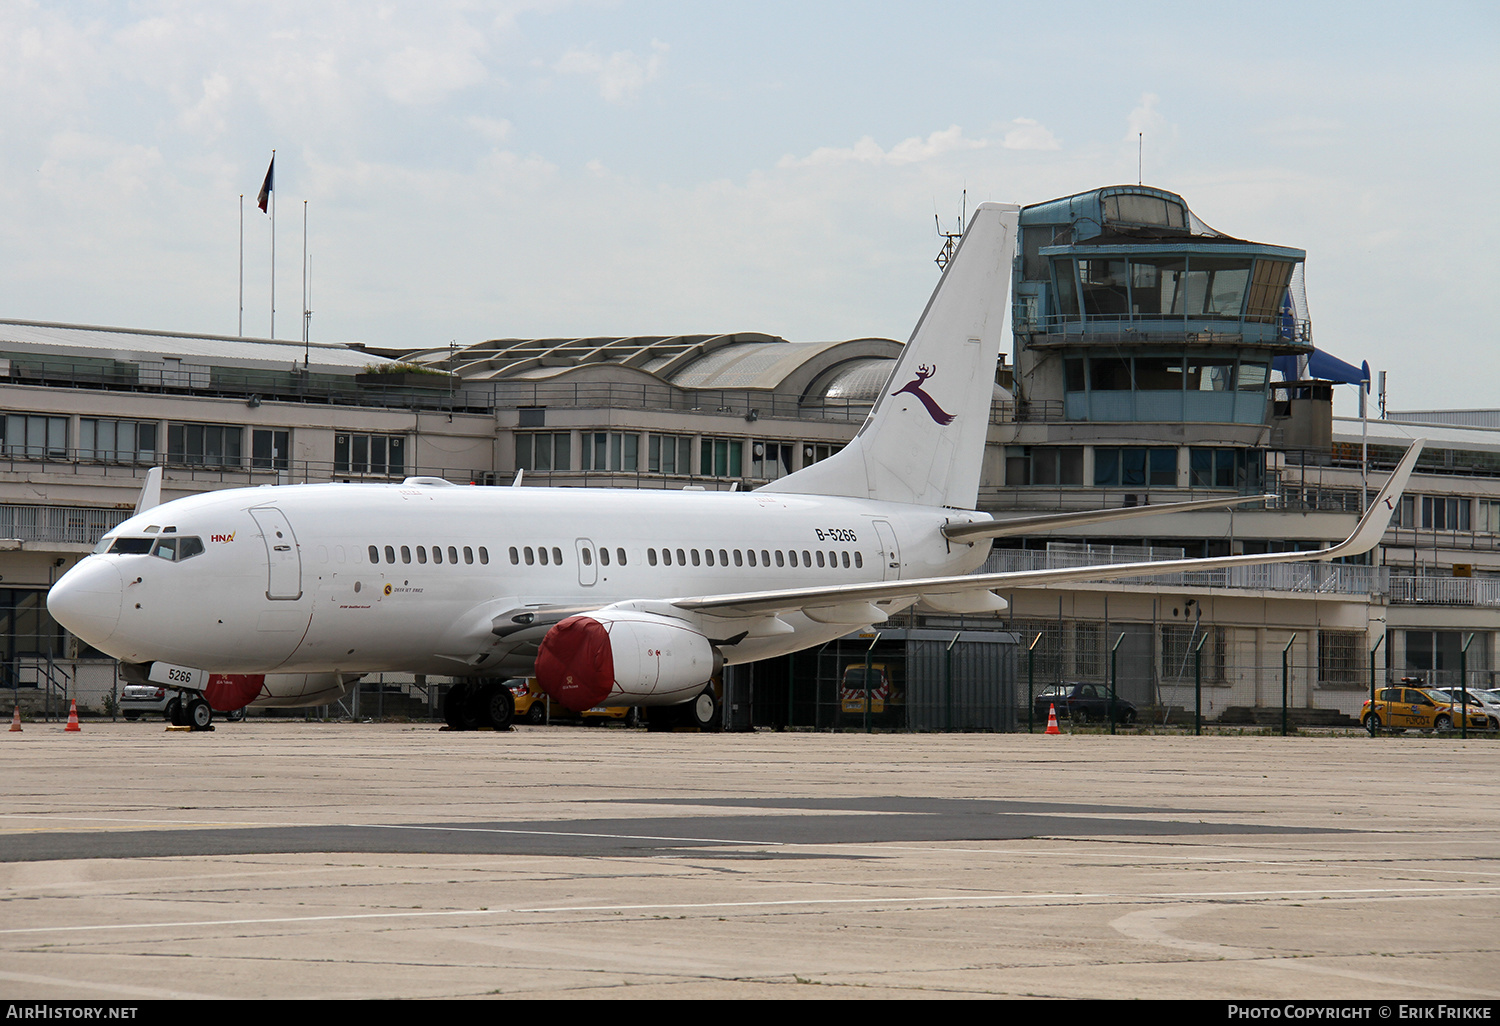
[0,186,1500,729]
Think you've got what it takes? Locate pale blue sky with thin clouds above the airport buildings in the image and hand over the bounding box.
[0,0,1500,413]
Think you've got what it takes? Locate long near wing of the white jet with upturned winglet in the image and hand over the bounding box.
[671,440,1425,624]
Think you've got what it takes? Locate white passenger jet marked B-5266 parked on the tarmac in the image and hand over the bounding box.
[48,204,1422,728]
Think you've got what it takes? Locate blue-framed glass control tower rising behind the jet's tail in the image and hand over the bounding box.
[992,186,1313,548]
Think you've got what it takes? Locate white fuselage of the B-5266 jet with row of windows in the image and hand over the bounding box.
[50,482,989,675]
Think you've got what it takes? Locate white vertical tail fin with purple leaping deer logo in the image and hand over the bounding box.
[762,203,1020,509]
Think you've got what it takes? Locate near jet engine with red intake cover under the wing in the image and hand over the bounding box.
[536,611,723,713]
